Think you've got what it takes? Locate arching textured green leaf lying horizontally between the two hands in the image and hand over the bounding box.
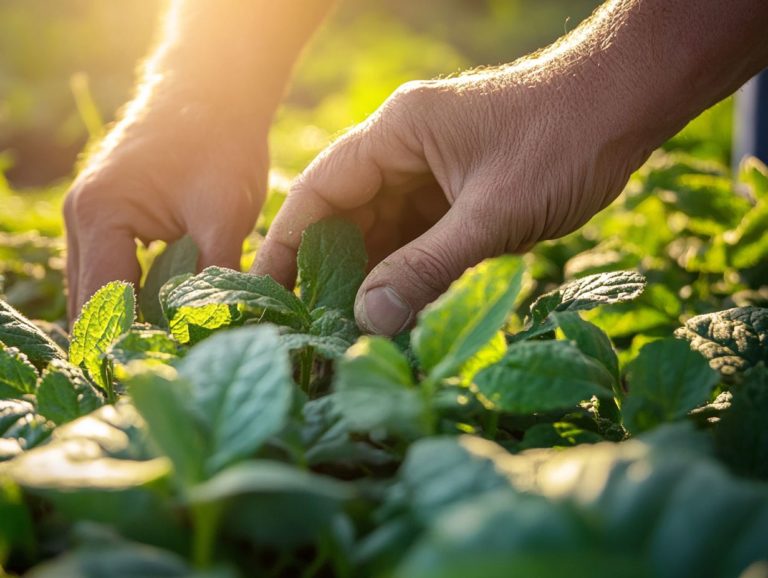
[165,267,311,330]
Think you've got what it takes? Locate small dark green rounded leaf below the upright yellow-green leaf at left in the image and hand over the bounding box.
[37,361,104,425]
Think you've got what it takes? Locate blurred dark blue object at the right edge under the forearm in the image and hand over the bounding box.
[732,69,768,169]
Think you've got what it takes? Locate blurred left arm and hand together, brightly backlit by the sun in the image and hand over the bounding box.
[64,0,333,319]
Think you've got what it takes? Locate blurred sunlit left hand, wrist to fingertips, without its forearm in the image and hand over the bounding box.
[64,96,268,318]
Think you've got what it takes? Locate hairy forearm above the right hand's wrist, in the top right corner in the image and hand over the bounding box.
[513,0,768,162]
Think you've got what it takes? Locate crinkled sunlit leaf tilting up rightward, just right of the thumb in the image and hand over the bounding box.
[513,271,646,341]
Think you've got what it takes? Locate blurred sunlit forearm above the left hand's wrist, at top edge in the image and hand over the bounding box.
[145,0,334,115]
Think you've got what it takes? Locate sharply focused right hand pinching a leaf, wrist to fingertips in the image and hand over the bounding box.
[252,67,652,335]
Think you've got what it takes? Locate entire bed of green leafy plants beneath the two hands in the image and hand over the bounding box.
[0,145,768,578]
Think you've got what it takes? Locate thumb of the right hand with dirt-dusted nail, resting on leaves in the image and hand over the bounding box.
[355,198,500,335]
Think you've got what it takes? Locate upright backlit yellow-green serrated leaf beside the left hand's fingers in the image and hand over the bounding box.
[69,281,136,390]
